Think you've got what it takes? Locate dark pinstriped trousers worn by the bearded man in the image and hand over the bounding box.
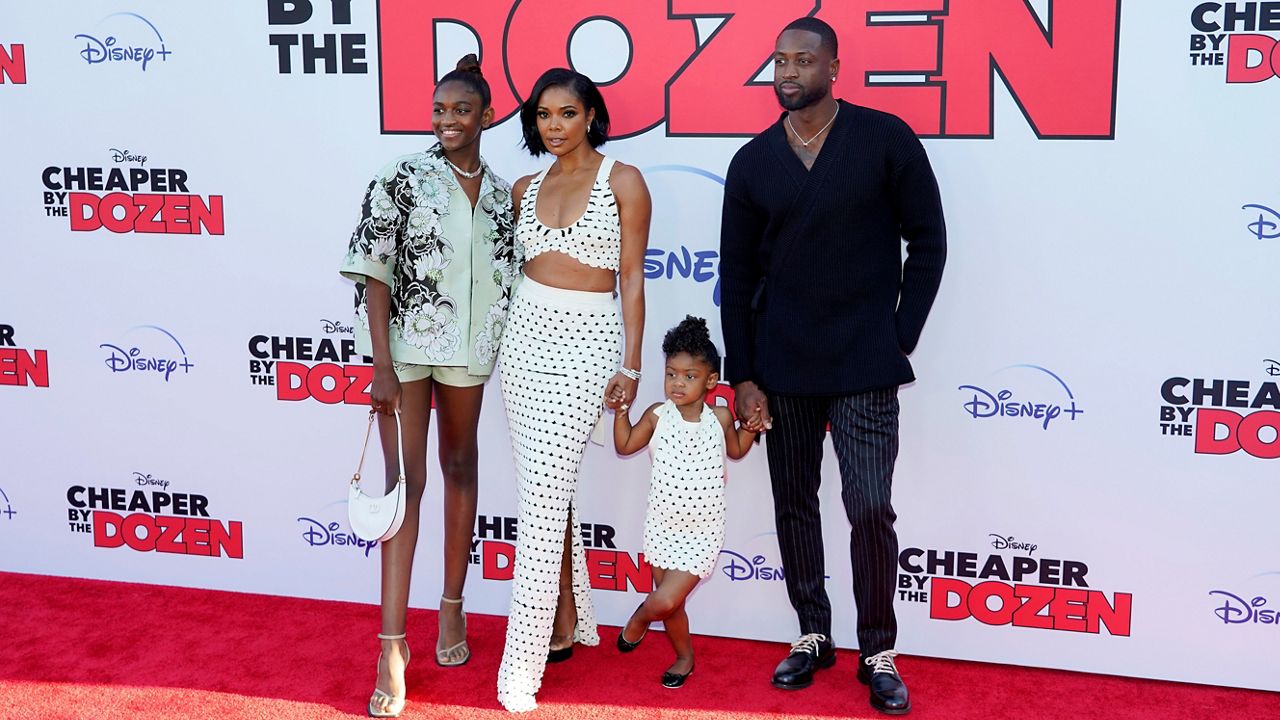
[765,387,899,657]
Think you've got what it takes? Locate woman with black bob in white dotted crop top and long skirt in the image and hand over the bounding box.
[488,69,650,711]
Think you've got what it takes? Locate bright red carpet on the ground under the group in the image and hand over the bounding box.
[0,573,1280,720]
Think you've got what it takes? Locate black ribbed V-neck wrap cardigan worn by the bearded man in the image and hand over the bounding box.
[721,100,946,395]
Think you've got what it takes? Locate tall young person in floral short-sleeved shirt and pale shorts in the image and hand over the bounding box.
[342,55,518,717]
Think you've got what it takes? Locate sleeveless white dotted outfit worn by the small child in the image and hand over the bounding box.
[644,400,724,578]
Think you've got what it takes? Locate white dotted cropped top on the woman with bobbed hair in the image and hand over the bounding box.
[516,158,622,272]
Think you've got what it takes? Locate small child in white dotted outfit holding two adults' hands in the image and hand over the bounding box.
[613,316,763,688]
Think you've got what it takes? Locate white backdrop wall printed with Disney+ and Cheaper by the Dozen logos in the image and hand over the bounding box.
[0,0,1280,689]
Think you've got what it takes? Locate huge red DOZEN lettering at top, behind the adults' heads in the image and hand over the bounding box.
[379,0,1120,138]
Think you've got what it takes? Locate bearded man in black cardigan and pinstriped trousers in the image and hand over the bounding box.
[721,18,946,715]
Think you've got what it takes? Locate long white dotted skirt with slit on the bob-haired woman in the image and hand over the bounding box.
[498,277,622,712]
